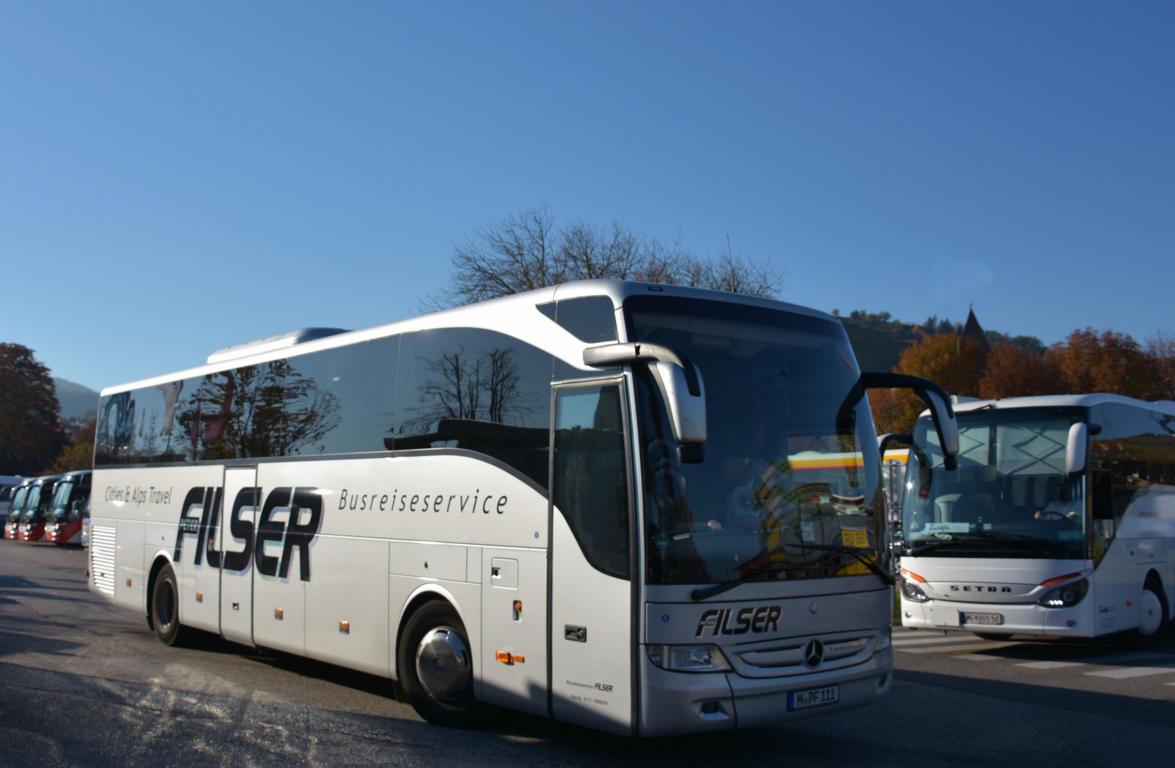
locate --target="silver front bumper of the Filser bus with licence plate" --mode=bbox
[640,648,893,736]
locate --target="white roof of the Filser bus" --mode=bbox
[101,279,837,397]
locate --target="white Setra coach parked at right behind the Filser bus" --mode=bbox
[901,395,1175,639]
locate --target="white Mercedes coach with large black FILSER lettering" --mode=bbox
[90,282,956,735]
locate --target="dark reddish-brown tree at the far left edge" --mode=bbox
[0,344,66,474]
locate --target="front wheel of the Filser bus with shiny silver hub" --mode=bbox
[397,602,475,727]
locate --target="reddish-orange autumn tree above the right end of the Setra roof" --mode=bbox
[1048,328,1156,399]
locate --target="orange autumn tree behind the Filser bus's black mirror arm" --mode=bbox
[870,334,988,432]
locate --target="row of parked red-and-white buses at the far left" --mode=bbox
[4,470,93,545]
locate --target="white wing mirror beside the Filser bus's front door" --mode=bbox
[584,342,706,450]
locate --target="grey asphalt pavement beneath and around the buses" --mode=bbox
[0,541,1175,768]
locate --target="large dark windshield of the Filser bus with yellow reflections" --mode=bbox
[625,297,881,584]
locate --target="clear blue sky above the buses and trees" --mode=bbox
[0,1,1175,389]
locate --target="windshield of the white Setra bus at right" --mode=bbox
[902,409,1088,559]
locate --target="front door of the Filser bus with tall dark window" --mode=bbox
[549,379,635,734]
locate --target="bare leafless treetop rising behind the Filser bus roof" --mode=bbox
[429,209,780,306]
